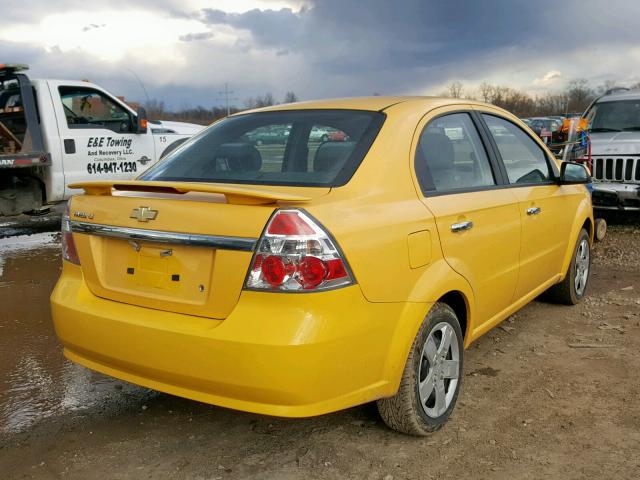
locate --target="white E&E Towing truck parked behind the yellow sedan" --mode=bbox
[0,64,204,217]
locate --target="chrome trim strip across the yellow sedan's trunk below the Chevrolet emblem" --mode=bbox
[70,221,257,252]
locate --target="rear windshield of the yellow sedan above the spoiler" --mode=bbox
[140,110,385,187]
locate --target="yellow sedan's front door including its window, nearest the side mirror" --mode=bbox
[482,111,575,301]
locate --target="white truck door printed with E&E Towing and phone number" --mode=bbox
[50,82,155,196]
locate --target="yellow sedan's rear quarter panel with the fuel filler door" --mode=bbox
[307,102,474,342]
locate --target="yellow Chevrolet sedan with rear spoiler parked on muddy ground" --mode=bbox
[51,97,593,435]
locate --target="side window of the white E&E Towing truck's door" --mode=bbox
[59,87,132,133]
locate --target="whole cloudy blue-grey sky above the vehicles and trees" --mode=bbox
[0,0,640,108]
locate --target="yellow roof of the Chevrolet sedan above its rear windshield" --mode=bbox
[237,96,492,115]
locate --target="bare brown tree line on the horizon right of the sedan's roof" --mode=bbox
[442,78,640,117]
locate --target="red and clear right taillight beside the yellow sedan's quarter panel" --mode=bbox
[245,210,354,292]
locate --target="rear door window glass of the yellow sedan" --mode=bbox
[415,113,496,192]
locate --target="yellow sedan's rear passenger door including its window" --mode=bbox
[415,106,521,335]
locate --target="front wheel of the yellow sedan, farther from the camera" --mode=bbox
[545,228,591,305]
